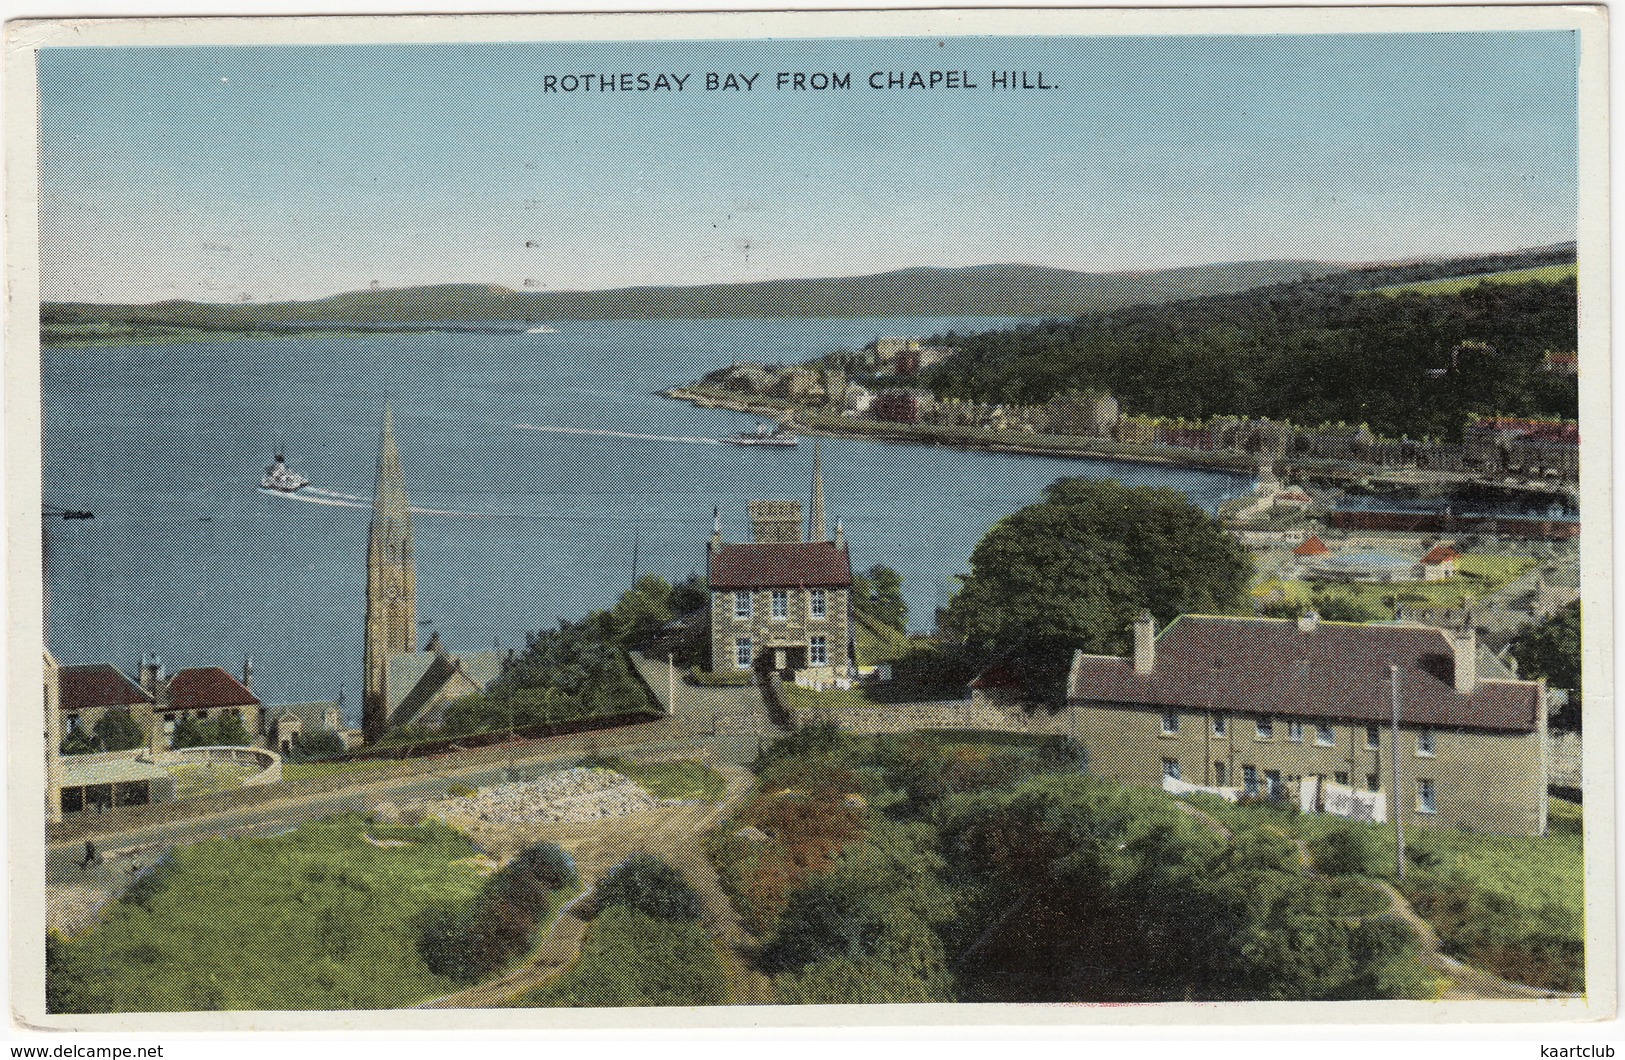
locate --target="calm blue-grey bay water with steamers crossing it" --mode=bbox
[44,319,1248,712]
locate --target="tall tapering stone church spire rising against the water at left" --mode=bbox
[361,405,418,743]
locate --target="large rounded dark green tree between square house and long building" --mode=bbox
[947,478,1251,699]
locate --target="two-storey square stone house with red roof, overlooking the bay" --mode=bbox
[709,497,852,681]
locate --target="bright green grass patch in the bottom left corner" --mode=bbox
[55,816,484,1013]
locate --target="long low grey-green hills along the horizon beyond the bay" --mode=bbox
[41,244,1575,335]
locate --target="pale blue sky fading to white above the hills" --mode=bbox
[39,33,1578,301]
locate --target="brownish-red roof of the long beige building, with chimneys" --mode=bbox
[1068,615,1544,733]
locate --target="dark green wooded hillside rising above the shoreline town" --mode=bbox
[923,245,1580,441]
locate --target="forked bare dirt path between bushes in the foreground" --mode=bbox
[418,764,774,1008]
